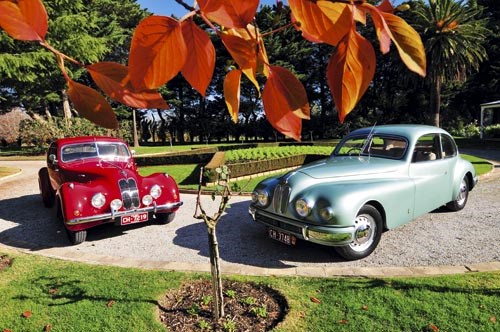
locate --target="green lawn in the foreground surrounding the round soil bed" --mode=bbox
[0,250,500,332]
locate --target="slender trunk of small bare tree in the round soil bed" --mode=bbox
[207,227,224,320]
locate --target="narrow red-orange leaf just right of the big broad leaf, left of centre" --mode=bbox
[182,20,215,97]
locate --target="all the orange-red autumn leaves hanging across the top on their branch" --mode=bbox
[0,0,426,140]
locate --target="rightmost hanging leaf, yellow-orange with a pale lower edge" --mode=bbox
[381,12,427,77]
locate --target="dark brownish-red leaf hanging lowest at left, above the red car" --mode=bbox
[67,80,118,129]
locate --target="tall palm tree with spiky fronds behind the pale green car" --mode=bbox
[416,0,488,127]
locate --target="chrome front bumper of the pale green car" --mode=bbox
[248,206,355,246]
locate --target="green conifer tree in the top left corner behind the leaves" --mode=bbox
[0,0,148,116]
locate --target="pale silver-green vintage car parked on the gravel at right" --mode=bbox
[249,125,478,260]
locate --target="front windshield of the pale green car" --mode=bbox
[333,134,408,159]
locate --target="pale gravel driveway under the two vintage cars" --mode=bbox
[0,151,500,269]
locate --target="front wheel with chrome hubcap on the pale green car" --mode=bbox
[335,205,382,260]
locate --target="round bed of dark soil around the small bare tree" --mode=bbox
[159,280,288,332]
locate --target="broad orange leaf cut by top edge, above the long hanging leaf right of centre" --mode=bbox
[288,0,352,46]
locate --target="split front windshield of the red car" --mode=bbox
[61,142,130,162]
